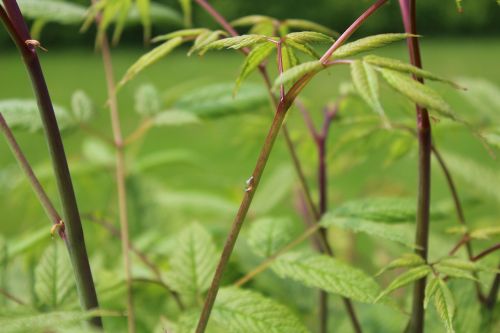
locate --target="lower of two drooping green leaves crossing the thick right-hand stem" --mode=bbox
[379,68,454,118]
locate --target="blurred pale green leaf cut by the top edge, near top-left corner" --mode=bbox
[17,0,87,24]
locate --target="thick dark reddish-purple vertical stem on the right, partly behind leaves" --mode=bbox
[399,0,432,333]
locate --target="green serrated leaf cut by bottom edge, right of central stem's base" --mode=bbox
[212,287,309,333]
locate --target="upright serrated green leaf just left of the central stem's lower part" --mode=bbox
[165,223,218,298]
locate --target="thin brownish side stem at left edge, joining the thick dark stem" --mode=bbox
[0,113,66,239]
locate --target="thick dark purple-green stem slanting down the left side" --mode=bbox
[0,0,102,327]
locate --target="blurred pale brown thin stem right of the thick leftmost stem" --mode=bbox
[97,26,135,333]
